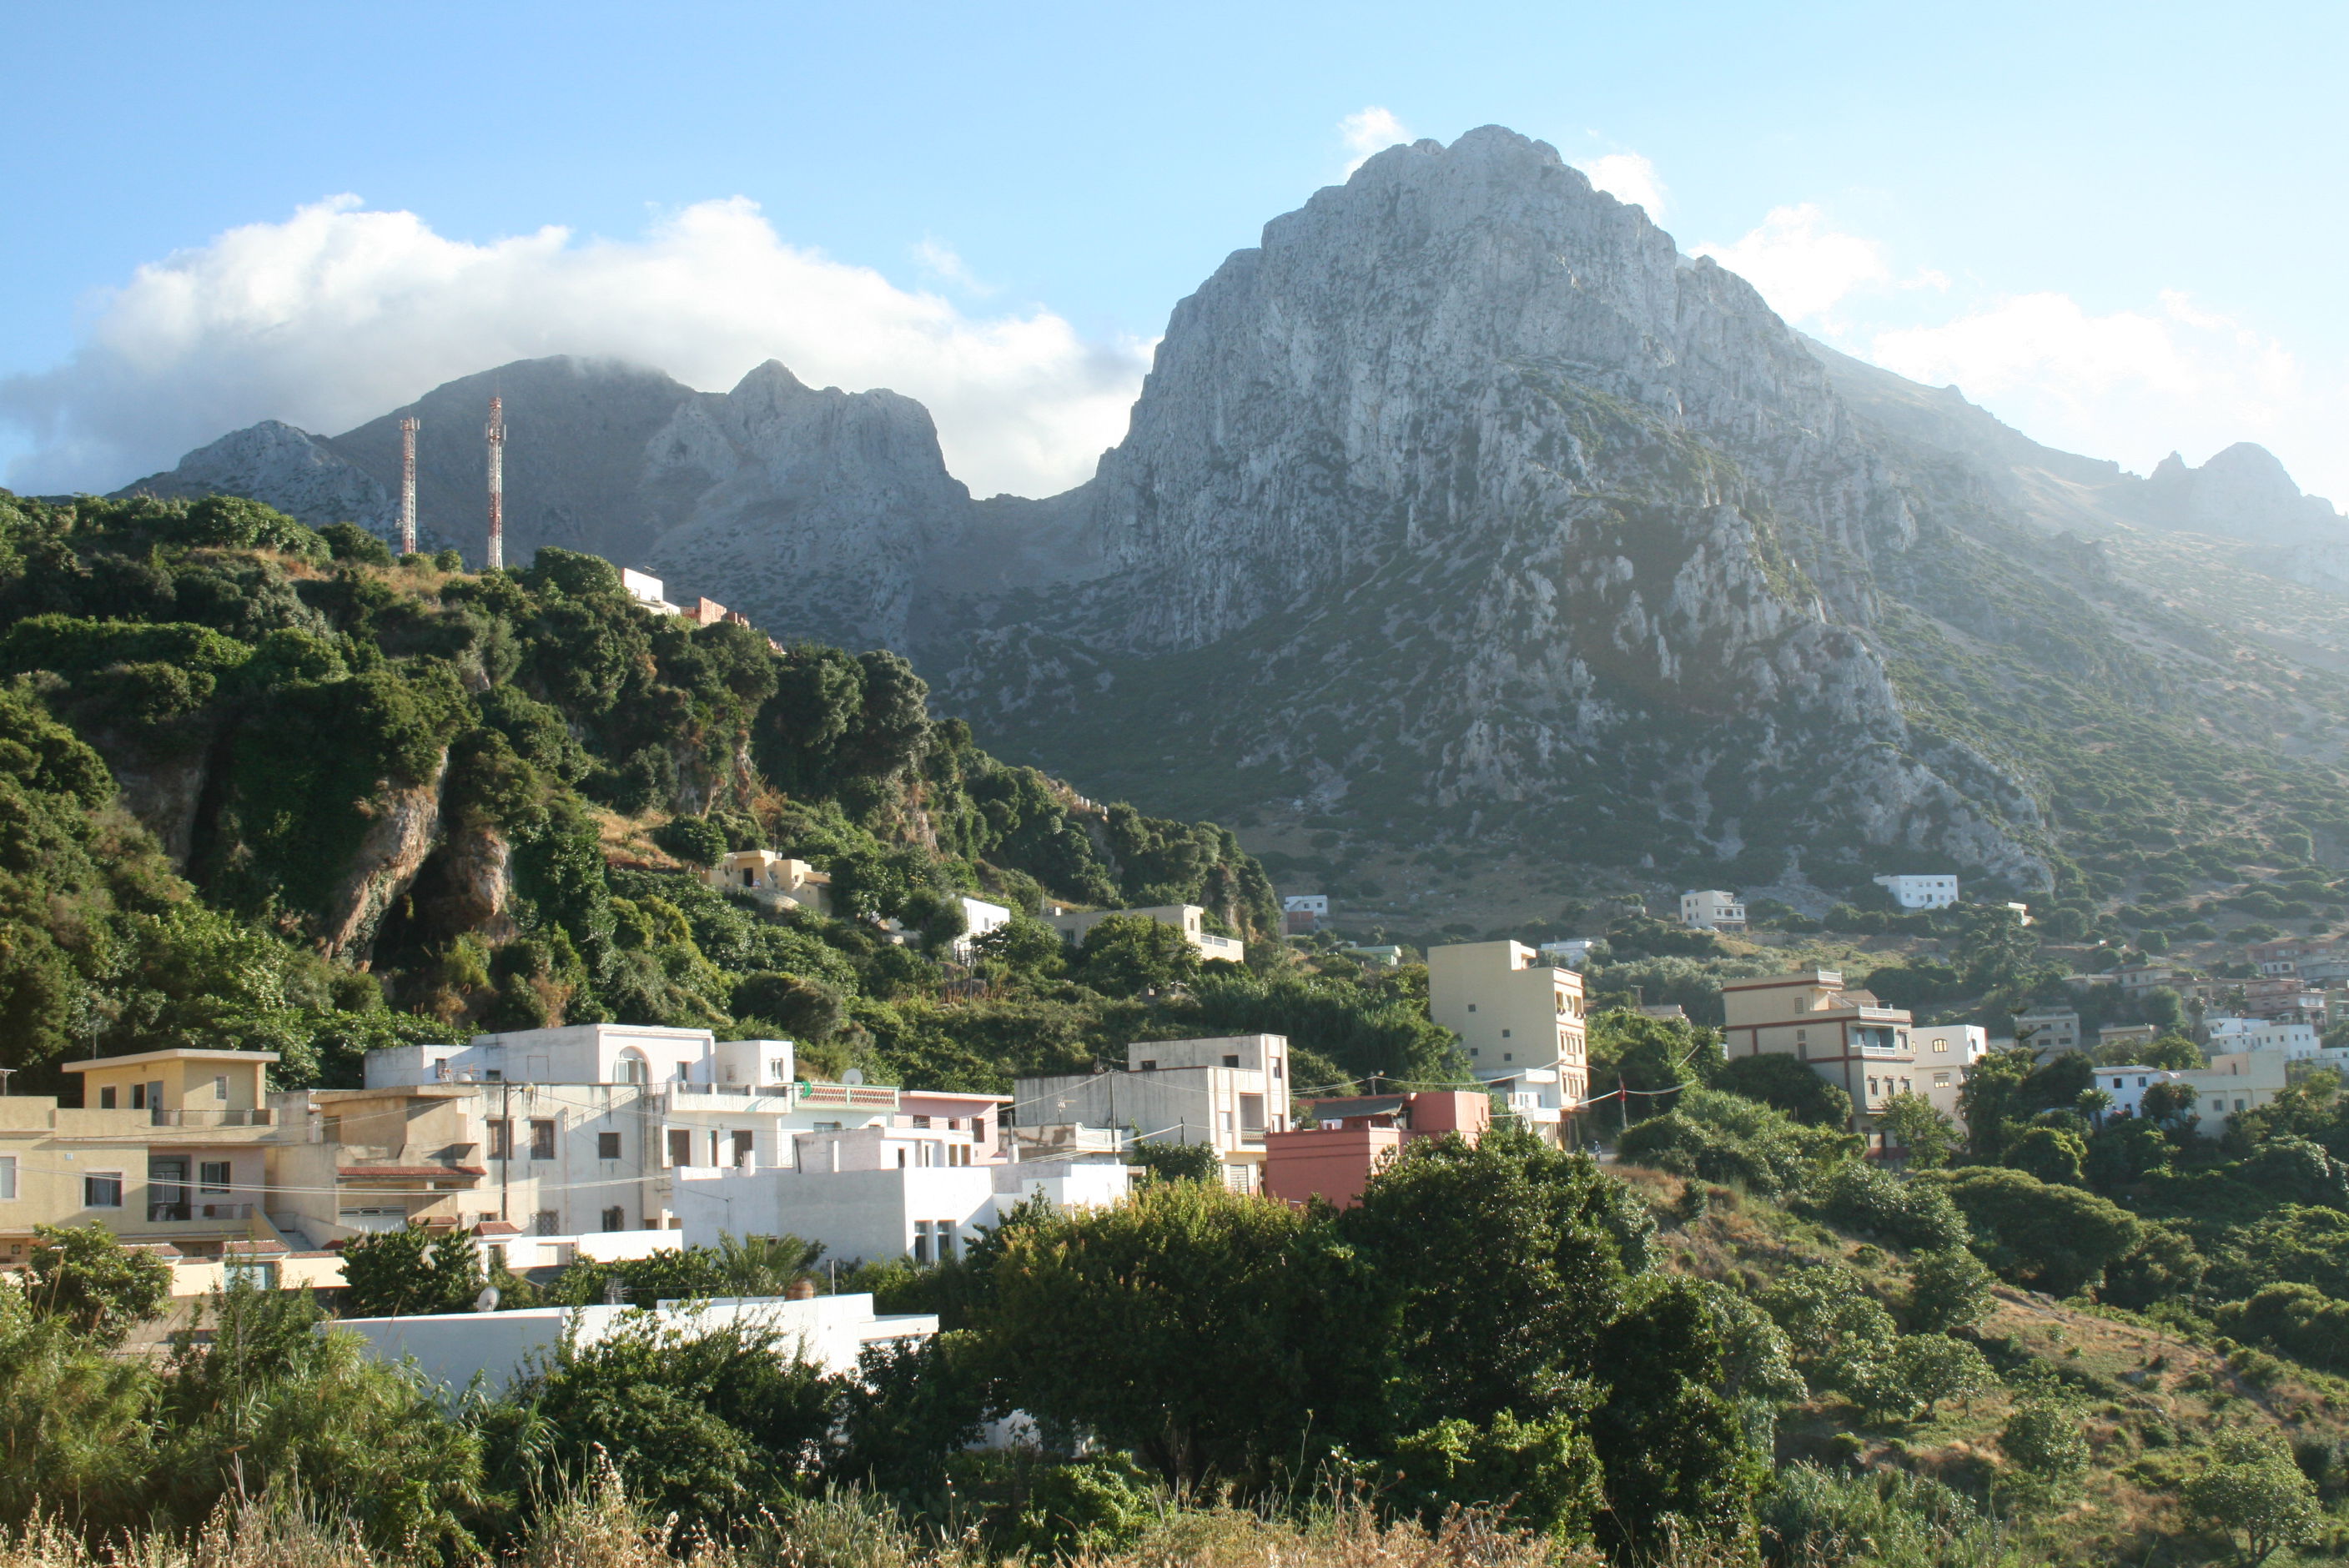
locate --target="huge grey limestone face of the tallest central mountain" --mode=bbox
[933,129,2044,882]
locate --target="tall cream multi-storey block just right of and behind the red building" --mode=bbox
[1428,942,1590,1143]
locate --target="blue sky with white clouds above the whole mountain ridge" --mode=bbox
[0,3,2349,500]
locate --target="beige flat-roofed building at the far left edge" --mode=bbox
[0,1049,282,1265]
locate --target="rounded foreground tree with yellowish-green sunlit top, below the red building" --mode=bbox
[973,1181,1391,1493]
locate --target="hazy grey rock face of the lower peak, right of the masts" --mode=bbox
[644,359,970,648]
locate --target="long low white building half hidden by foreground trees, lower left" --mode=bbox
[335,1296,938,1395]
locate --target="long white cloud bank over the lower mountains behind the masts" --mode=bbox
[0,197,1149,495]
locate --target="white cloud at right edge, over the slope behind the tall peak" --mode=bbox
[1870,291,2349,498]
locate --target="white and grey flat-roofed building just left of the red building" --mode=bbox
[1013,1035,1292,1193]
